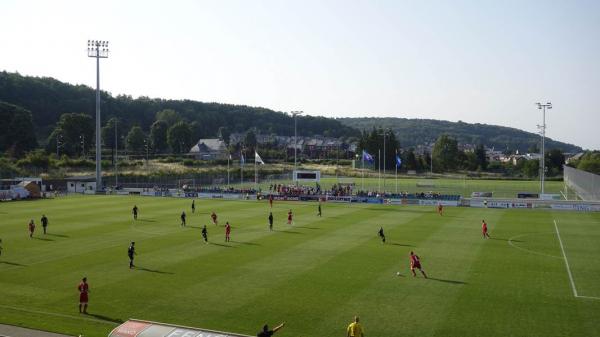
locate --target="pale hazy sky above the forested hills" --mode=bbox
[0,0,600,149]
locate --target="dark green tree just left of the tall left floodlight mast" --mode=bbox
[46,113,95,156]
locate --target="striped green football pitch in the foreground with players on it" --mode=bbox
[0,196,600,337]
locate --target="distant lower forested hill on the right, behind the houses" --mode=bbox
[337,118,582,152]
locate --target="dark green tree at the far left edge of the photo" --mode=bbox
[0,102,37,156]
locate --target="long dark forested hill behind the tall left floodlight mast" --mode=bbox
[0,72,359,143]
